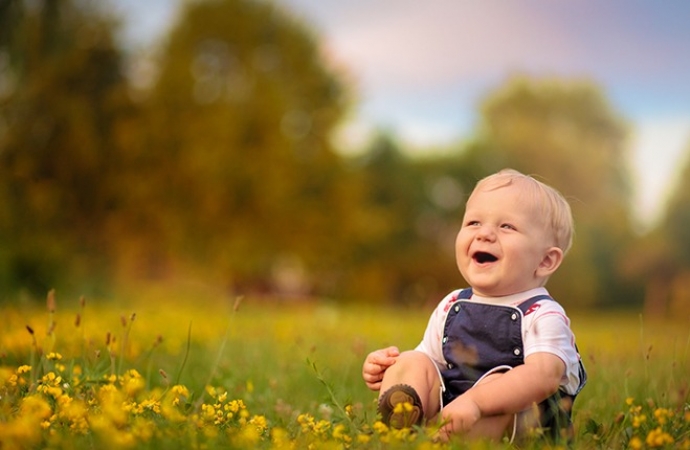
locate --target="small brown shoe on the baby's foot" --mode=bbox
[378,384,424,429]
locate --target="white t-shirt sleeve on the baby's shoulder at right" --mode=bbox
[523,300,580,394]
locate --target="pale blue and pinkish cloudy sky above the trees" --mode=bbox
[111,0,690,230]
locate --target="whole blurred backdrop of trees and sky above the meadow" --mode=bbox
[0,0,690,316]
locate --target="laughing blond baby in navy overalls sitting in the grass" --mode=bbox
[362,169,587,441]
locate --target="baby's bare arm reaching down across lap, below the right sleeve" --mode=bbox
[440,352,565,438]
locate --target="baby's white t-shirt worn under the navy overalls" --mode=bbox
[416,287,580,395]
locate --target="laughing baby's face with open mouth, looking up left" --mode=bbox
[455,184,554,297]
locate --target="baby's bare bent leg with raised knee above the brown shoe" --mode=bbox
[379,351,441,418]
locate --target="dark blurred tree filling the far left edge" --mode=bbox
[0,0,129,295]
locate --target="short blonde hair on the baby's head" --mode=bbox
[474,169,575,254]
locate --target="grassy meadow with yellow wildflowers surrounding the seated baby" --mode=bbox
[0,290,690,450]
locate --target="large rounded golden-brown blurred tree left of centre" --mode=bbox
[140,0,354,296]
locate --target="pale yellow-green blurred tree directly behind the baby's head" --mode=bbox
[456,77,641,306]
